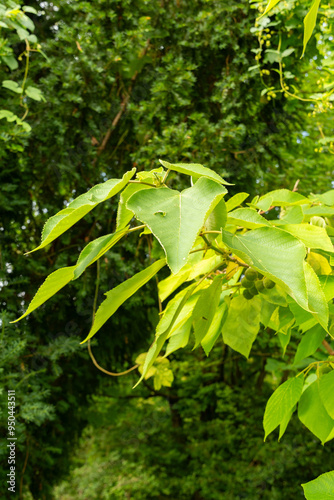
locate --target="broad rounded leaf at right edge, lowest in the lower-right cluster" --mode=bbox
[298,381,334,444]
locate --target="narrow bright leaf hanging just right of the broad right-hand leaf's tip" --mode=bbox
[304,261,329,331]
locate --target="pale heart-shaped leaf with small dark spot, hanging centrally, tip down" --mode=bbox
[127,177,226,274]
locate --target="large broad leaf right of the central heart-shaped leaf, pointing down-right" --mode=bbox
[222,227,308,309]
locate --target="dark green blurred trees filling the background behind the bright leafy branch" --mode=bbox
[0,0,334,500]
